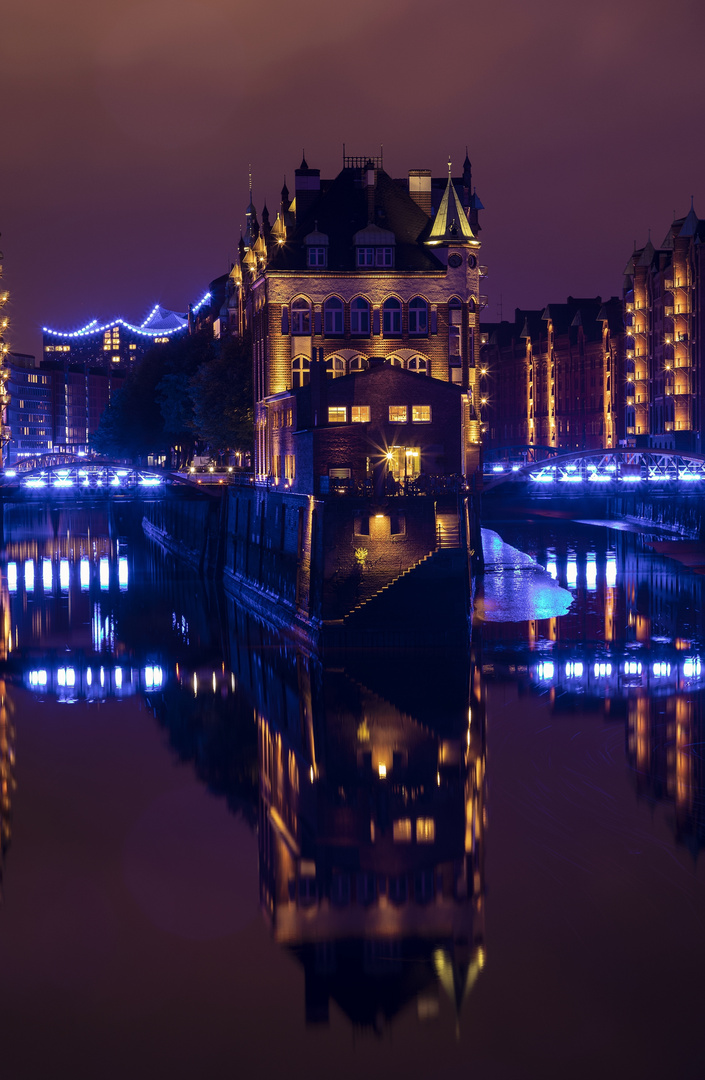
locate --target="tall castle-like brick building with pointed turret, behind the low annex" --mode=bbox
[224,149,485,485]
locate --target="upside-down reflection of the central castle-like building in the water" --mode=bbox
[250,639,486,1029]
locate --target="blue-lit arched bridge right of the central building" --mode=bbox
[484,448,705,498]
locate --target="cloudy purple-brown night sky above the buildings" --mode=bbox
[0,0,705,353]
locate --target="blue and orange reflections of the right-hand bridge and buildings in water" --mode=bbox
[475,527,705,855]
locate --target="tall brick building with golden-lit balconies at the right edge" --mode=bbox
[624,206,705,453]
